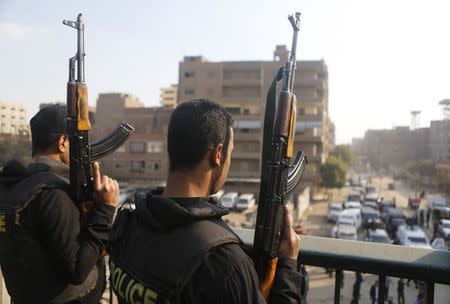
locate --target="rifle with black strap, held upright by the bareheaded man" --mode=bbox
[253,13,308,299]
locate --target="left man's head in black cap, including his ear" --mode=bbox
[30,105,69,164]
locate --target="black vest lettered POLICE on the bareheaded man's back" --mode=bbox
[109,198,240,304]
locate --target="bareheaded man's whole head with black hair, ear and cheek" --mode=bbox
[167,99,233,194]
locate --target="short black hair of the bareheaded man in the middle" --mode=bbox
[167,99,233,171]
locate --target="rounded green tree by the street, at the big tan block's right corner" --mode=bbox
[320,155,348,188]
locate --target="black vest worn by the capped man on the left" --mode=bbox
[0,161,98,303]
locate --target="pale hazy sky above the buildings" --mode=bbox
[0,0,450,143]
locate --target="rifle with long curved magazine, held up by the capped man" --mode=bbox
[63,14,134,203]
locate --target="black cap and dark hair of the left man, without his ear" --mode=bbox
[30,105,66,156]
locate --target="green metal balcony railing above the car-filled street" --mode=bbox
[233,228,450,304]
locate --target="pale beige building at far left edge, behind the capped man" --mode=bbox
[0,101,29,135]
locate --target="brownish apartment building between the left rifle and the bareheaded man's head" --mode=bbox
[93,93,172,187]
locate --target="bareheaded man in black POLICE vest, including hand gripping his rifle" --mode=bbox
[110,100,301,303]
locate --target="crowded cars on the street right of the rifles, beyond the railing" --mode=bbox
[327,189,450,250]
